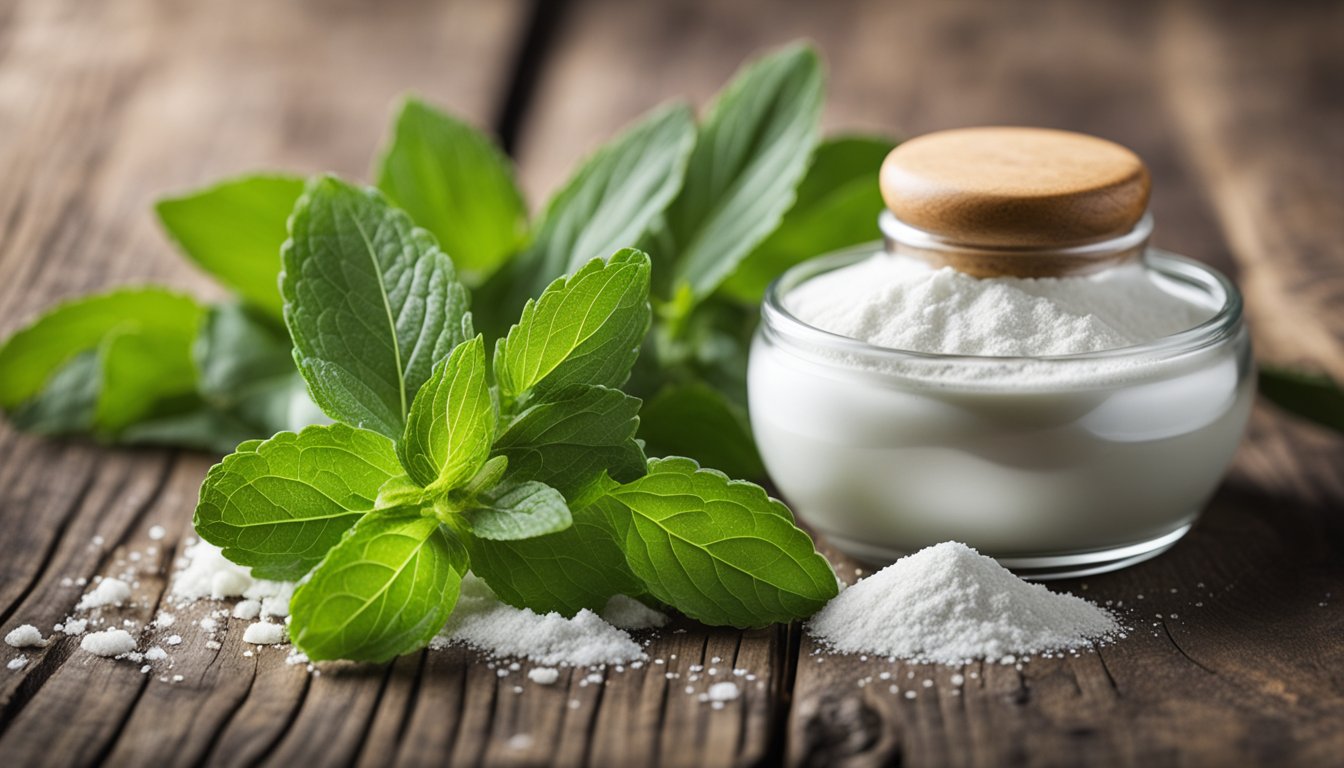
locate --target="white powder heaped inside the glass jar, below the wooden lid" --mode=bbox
[786,253,1212,356]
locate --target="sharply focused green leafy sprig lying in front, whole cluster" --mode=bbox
[195,176,836,662]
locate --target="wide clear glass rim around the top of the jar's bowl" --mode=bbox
[761,241,1243,366]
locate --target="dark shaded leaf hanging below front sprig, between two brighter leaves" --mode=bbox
[466,499,642,616]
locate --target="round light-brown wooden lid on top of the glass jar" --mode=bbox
[880,128,1150,247]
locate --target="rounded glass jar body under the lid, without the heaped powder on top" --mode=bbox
[749,238,1254,578]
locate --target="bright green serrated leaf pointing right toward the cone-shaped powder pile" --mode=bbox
[607,459,836,627]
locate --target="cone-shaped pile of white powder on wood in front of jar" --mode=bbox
[808,542,1120,664]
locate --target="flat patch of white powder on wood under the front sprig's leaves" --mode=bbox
[433,574,645,666]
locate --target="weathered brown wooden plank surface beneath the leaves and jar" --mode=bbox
[0,0,1344,767]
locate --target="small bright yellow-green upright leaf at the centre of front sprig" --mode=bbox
[396,336,495,491]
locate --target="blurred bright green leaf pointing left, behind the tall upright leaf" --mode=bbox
[155,175,304,319]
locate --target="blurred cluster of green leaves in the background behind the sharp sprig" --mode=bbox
[0,46,891,477]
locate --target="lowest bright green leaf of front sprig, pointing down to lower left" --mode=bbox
[289,508,468,663]
